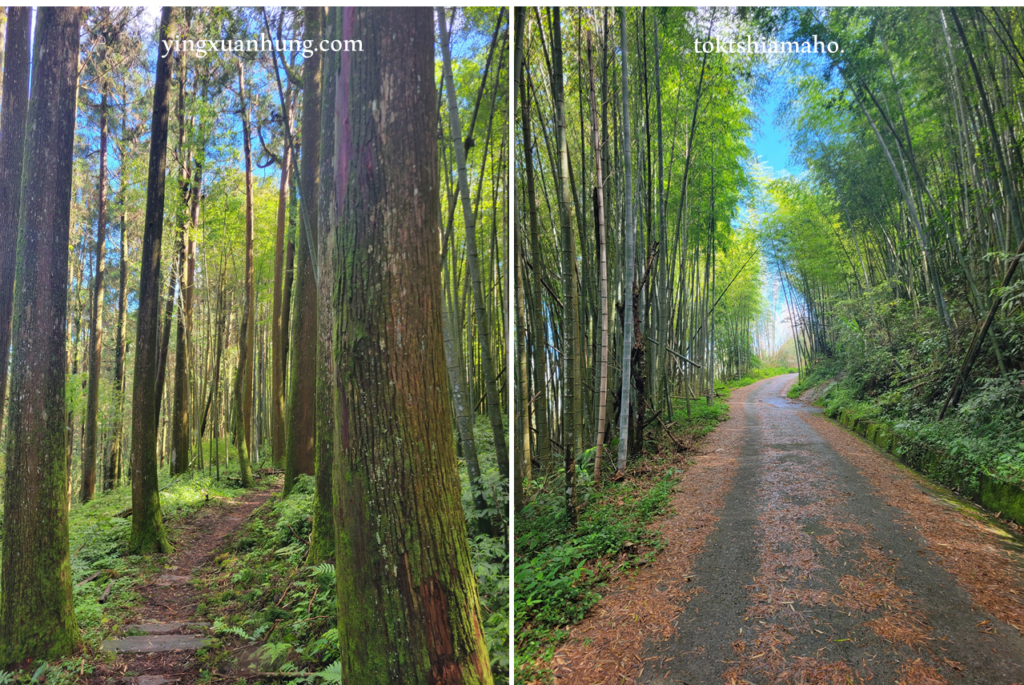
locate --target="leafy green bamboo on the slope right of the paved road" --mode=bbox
[751,6,1024,417]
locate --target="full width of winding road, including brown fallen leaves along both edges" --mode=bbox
[551,375,1024,685]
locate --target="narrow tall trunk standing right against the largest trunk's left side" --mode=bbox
[311,5,340,559]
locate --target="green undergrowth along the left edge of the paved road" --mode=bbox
[512,369,796,683]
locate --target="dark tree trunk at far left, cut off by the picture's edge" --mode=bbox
[0,5,32,428]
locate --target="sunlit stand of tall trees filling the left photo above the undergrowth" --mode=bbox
[0,6,507,683]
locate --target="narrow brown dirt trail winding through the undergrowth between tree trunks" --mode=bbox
[90,484,281,684]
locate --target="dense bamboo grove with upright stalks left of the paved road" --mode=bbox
[512,6,767,521]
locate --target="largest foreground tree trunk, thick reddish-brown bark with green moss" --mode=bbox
[327,7,494,685]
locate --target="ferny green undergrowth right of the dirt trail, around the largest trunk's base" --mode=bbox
[196,466,510,683]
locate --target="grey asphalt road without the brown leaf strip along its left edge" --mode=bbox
[640,375,1024,685]
